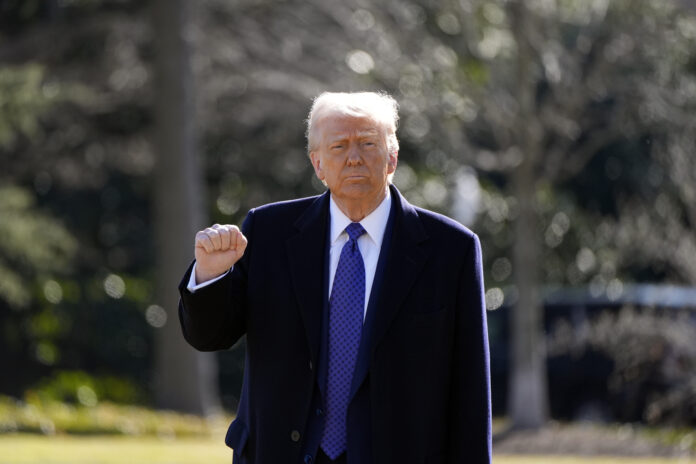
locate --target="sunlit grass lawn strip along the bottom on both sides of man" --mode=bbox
[0,434,696,464]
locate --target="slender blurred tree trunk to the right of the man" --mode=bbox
[508,0,548,428]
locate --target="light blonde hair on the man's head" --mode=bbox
[305,92,399,155]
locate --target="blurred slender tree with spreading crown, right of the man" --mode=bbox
[372,1,690,427]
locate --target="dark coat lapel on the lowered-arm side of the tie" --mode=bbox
[351,186,428,396]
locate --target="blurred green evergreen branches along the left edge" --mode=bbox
[0,65,77,391]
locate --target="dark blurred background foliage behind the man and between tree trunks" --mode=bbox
[0,0,696,422]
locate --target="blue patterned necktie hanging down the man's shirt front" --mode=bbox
[321,222,365,459]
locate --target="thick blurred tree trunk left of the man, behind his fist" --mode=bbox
[152,0,219,414]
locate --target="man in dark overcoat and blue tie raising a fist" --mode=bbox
[180,93,491,464]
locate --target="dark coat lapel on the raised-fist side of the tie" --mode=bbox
[286,191,329,372]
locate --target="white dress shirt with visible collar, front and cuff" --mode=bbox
[186,192,391,320]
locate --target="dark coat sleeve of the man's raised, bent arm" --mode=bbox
[179,210,254,351]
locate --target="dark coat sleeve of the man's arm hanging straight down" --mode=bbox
[448,235,492,464]
